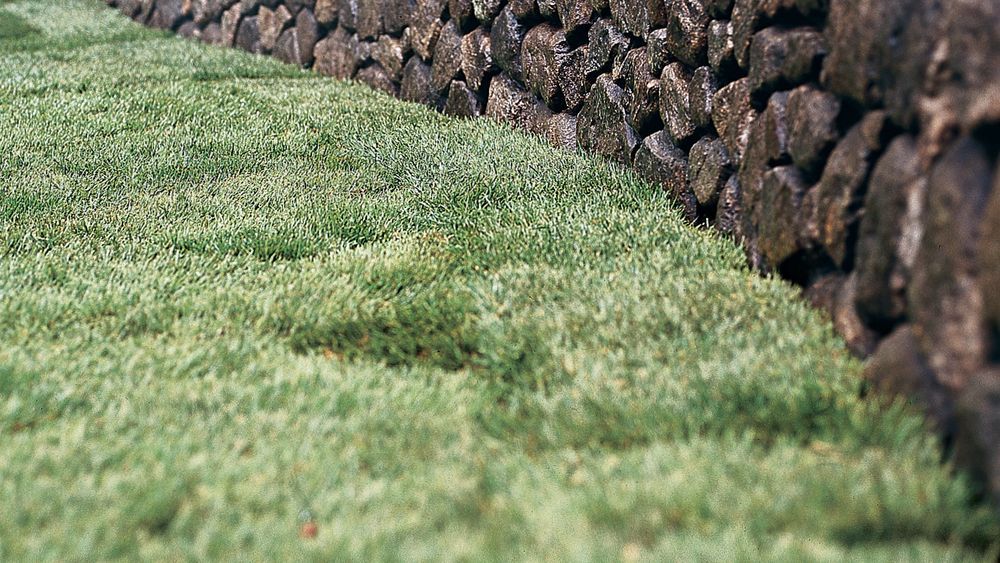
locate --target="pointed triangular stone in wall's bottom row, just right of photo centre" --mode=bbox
[576,74,639,164]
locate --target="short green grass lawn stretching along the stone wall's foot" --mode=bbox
[0,0,998,561]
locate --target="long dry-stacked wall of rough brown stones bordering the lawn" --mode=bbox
[107,0,1000,506]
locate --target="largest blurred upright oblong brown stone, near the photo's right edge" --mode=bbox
[909,138,991,392]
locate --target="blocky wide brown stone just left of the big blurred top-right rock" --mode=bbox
[748,27,826,98]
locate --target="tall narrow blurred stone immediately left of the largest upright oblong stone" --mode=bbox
[855,135,924,330]
